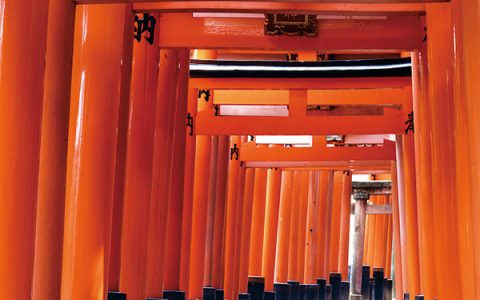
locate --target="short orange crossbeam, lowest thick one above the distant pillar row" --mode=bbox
[241,137,395,162]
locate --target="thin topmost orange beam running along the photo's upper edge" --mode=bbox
[129,0,425,15]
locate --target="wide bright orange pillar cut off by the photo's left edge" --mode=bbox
[0,0,49,299]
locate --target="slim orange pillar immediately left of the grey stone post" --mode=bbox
[338,171,352,280]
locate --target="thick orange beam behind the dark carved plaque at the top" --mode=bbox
[157,13,423,51]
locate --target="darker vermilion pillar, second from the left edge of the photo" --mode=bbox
[32,0,75,300]
